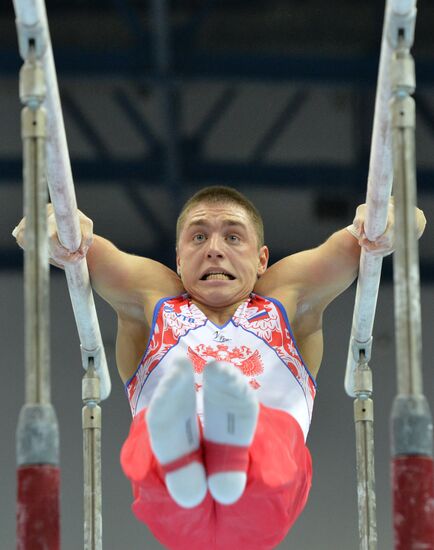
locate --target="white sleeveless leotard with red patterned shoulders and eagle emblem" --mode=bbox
[125,294,316,439]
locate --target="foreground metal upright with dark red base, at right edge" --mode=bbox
[389,0,434,550]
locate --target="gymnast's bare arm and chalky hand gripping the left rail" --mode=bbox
[13,205,183,321]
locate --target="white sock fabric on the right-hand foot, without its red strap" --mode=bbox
[203,362,259,504]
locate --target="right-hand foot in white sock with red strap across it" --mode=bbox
[204,363,259,504]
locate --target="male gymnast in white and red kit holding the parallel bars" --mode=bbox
[13,186,426,550]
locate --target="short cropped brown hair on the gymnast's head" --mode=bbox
[176,185,264,248]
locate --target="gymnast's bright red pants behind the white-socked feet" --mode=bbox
[121,405,312,550]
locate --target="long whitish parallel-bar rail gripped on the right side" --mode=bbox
[345,0,416,397]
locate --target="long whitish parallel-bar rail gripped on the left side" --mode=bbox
[14,0,111,399]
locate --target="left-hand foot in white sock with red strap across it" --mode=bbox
[146,360,207,508]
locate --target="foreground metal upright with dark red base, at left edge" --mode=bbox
[13,5,60,550]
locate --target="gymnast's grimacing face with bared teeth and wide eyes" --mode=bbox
[177,202,268,308]
